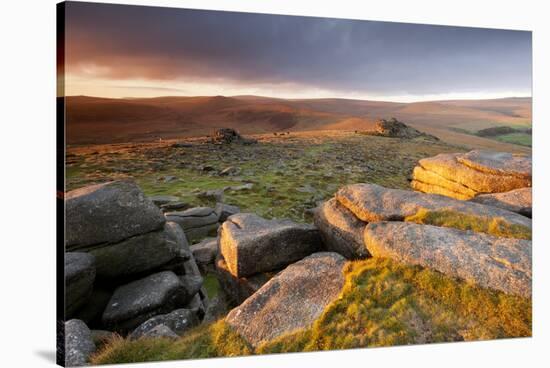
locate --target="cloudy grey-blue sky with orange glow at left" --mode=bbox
[65,2,532,102]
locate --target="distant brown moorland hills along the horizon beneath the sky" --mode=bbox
[66,96,531,150]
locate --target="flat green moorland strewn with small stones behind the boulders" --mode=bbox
[66,131,464,222]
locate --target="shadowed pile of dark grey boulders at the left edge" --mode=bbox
[65,181,211,366]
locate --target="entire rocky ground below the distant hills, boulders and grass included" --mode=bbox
[65,129,532,365]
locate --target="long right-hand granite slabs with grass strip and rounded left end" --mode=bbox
[314,183,532,298]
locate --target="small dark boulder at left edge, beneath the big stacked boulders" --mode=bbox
[65,252,96,316]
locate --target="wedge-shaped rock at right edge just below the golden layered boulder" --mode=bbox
[471,188,533,217]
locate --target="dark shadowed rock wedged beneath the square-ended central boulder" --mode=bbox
[216,257,277,305]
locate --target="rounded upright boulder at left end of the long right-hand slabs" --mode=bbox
[313,198,370,259]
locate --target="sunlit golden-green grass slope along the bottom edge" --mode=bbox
[92,258,532,364]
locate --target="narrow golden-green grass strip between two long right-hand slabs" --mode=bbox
[405,209,531,240]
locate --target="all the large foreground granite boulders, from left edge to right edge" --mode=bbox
[65,151,532,365]
